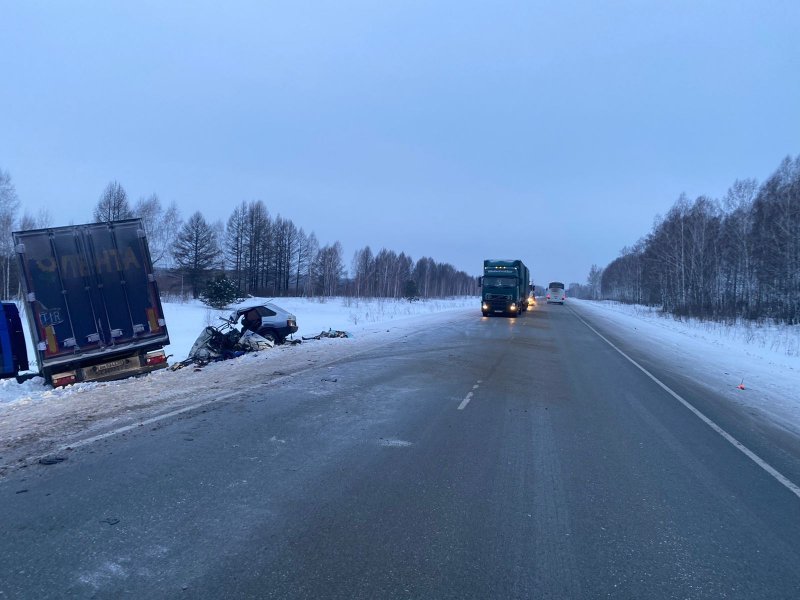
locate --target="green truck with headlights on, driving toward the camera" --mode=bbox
[480,259,531,317]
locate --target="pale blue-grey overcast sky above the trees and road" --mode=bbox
[0,0,800,283]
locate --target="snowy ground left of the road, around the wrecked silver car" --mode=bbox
[0,298,476,476]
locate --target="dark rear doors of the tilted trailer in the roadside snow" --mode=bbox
[13,219,169,380]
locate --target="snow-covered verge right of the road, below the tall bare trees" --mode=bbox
[569,299,800,436]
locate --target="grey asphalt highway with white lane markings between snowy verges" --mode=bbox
[0,305,800,599]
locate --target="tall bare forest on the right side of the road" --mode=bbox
[590,156,800,324]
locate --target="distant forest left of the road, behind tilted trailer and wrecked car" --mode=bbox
[0,169,477,299]
